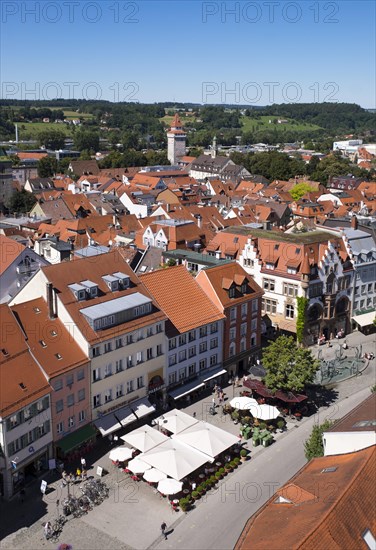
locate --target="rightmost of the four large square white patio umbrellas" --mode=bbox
[172,422,239,458]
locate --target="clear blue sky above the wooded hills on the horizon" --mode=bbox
[0,0,376,108]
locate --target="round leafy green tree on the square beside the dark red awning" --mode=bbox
[263,336,319,391]
